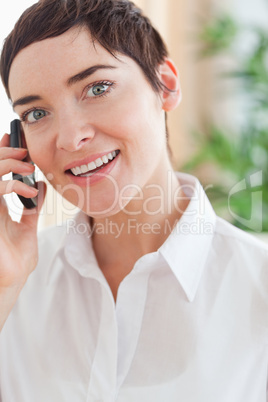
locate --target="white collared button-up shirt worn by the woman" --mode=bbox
[0,174,268,402]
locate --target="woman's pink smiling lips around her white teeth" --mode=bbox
[65,152,120,187]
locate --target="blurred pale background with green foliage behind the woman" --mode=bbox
[0,0,268,237]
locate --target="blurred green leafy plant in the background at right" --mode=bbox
[184,16,268,231]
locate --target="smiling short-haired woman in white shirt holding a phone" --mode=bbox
[0,0,268,402]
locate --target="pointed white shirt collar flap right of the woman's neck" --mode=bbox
[159,173,216,301]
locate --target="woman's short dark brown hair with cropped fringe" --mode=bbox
[0,0,168,98]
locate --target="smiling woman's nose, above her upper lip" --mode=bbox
[56,108,95,152]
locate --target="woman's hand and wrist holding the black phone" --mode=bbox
[0,134,46,328]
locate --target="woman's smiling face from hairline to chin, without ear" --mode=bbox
[9,28,177,217]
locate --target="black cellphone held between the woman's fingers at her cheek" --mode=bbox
[10,119,37,209]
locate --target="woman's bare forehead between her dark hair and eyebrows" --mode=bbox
[9,27,136,100]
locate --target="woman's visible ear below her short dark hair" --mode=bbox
[159,58,181,112]
